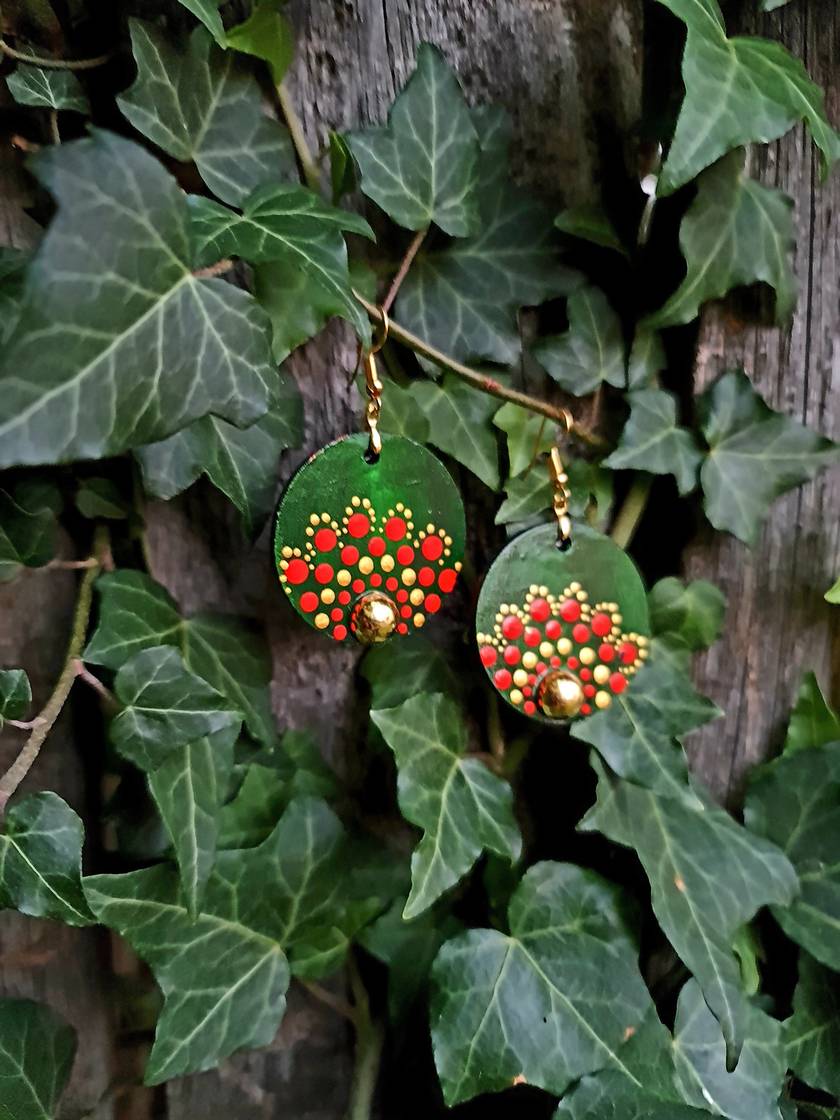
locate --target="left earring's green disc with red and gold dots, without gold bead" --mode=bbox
[274,433,466,642]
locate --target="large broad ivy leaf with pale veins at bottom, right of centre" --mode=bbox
[430,864,651,1107]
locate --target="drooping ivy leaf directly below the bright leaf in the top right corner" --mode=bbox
[645,151,796,327]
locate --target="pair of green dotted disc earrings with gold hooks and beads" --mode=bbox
[274,327,648,724]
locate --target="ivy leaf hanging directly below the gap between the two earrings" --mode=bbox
[371,692,522,921]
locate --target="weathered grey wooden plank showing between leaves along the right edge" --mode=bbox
[687,0,840,803]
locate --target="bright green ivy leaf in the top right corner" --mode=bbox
[657,0,840,195]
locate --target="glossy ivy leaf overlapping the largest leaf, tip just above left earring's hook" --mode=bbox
[190,185,373,339]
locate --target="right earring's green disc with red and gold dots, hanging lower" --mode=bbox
[476,525,650,724]
